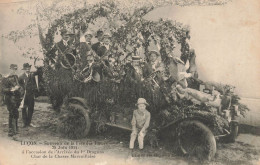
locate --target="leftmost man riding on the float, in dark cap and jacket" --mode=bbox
[46,29,76,64]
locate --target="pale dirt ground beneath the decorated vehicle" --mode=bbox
[0,97,260,165]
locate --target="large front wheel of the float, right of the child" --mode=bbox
[177,120,216,160]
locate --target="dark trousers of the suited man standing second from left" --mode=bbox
[22,95,34,126]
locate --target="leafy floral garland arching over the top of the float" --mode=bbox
[43,1,189,51]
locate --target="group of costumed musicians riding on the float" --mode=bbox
[46,29,215,104]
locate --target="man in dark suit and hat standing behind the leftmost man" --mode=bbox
[19,63,37,127]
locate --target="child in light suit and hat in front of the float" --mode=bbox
[129,98,151,149]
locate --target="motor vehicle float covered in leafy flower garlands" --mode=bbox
[31,1,248,160]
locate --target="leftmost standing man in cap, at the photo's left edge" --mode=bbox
[2,64,22,136]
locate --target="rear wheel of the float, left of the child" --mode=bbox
[60,98,91,139]
